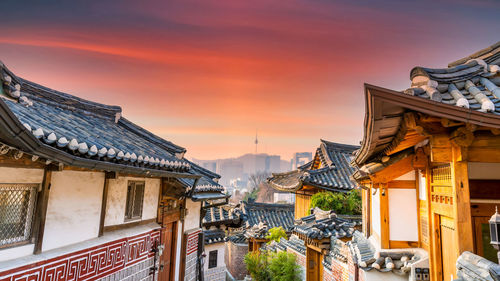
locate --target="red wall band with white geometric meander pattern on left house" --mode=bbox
[0,230,160,281]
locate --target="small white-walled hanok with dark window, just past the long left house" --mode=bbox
[203,204,242,281]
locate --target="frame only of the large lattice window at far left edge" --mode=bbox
[0,183,40,249]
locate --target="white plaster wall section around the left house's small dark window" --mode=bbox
[104,177,161,226]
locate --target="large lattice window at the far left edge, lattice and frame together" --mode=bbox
[0,184,38,247]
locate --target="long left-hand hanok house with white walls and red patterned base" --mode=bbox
[0,61,225,280]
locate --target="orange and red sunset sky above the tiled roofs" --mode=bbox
[0,0,500,159]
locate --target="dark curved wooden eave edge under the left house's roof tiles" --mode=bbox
[0,99,201,179]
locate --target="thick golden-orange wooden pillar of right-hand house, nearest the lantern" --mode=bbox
[451,145,474,255]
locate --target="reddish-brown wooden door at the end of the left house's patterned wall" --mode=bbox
[158,222,177,281]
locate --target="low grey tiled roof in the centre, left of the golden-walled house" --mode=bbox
[241,202,294,231]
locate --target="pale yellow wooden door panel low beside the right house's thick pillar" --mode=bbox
[440,216,457,281]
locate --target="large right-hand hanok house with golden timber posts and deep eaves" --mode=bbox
[353,42,500,280]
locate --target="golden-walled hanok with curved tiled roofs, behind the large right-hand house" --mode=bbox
[268,140,361,281]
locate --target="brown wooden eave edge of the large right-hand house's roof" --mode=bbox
[354,83,500,165]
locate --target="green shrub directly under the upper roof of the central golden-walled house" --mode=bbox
[311,190,361,215]
